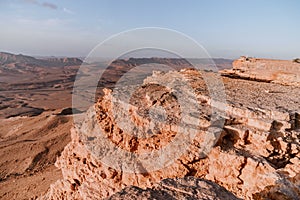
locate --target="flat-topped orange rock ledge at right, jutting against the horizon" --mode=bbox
[222,56,300,86]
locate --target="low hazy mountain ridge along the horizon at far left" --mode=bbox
[0,52,82,67]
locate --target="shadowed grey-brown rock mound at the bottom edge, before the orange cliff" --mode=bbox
[108,177,239,200]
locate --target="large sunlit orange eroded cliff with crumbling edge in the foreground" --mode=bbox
[41,70,300,199]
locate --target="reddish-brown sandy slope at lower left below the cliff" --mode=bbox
[0,112,72,199]
